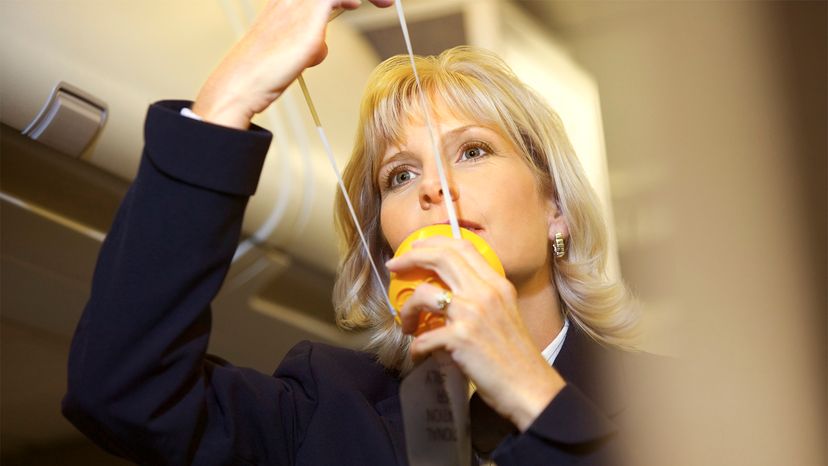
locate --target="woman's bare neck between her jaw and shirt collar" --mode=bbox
[515,268,564,351]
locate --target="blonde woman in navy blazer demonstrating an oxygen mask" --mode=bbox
[63,0,633,465]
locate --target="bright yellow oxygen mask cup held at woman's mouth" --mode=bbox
[388,225,506,336]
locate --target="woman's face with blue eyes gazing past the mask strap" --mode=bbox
[378,108,562,285]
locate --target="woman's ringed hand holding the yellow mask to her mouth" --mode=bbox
[387,236,565,431]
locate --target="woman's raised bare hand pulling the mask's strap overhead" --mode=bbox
[193,0,393,129]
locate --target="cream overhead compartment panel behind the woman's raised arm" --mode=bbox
[0,0,378,272]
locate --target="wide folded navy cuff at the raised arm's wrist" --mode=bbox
[144,100,272,196]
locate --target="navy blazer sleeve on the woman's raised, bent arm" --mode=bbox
[62,101,316,465]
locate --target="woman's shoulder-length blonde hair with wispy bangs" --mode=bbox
[333,46,636,371]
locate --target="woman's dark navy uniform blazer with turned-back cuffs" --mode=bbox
[63,101,623,466]
